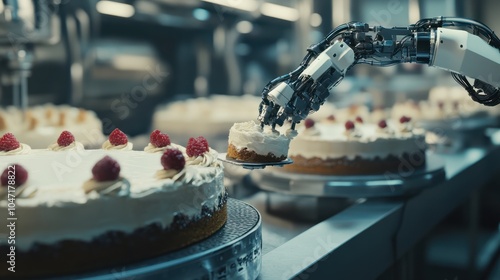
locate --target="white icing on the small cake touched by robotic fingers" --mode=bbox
[228,121,293,157]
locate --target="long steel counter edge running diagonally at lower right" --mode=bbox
[236,146,500,279]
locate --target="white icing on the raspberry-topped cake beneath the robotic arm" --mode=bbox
[288,123,425,159]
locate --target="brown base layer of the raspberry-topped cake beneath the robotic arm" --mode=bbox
[283,151,426,175]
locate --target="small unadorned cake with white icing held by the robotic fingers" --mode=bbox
[227,121,295,162]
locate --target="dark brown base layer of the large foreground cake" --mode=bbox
[0,197,227,278]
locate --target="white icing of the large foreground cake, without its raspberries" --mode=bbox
[0,150,225,250]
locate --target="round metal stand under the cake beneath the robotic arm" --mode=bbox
[250,154,445,198]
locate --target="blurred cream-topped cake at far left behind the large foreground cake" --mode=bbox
[0,104,105,149]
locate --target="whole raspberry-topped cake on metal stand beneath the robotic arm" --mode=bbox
[283,118,426,175]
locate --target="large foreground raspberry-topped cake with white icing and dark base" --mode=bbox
[0,130,227,277]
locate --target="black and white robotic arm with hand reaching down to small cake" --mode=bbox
[259,17,500,129]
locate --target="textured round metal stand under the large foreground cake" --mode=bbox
[62,198,262,280]
